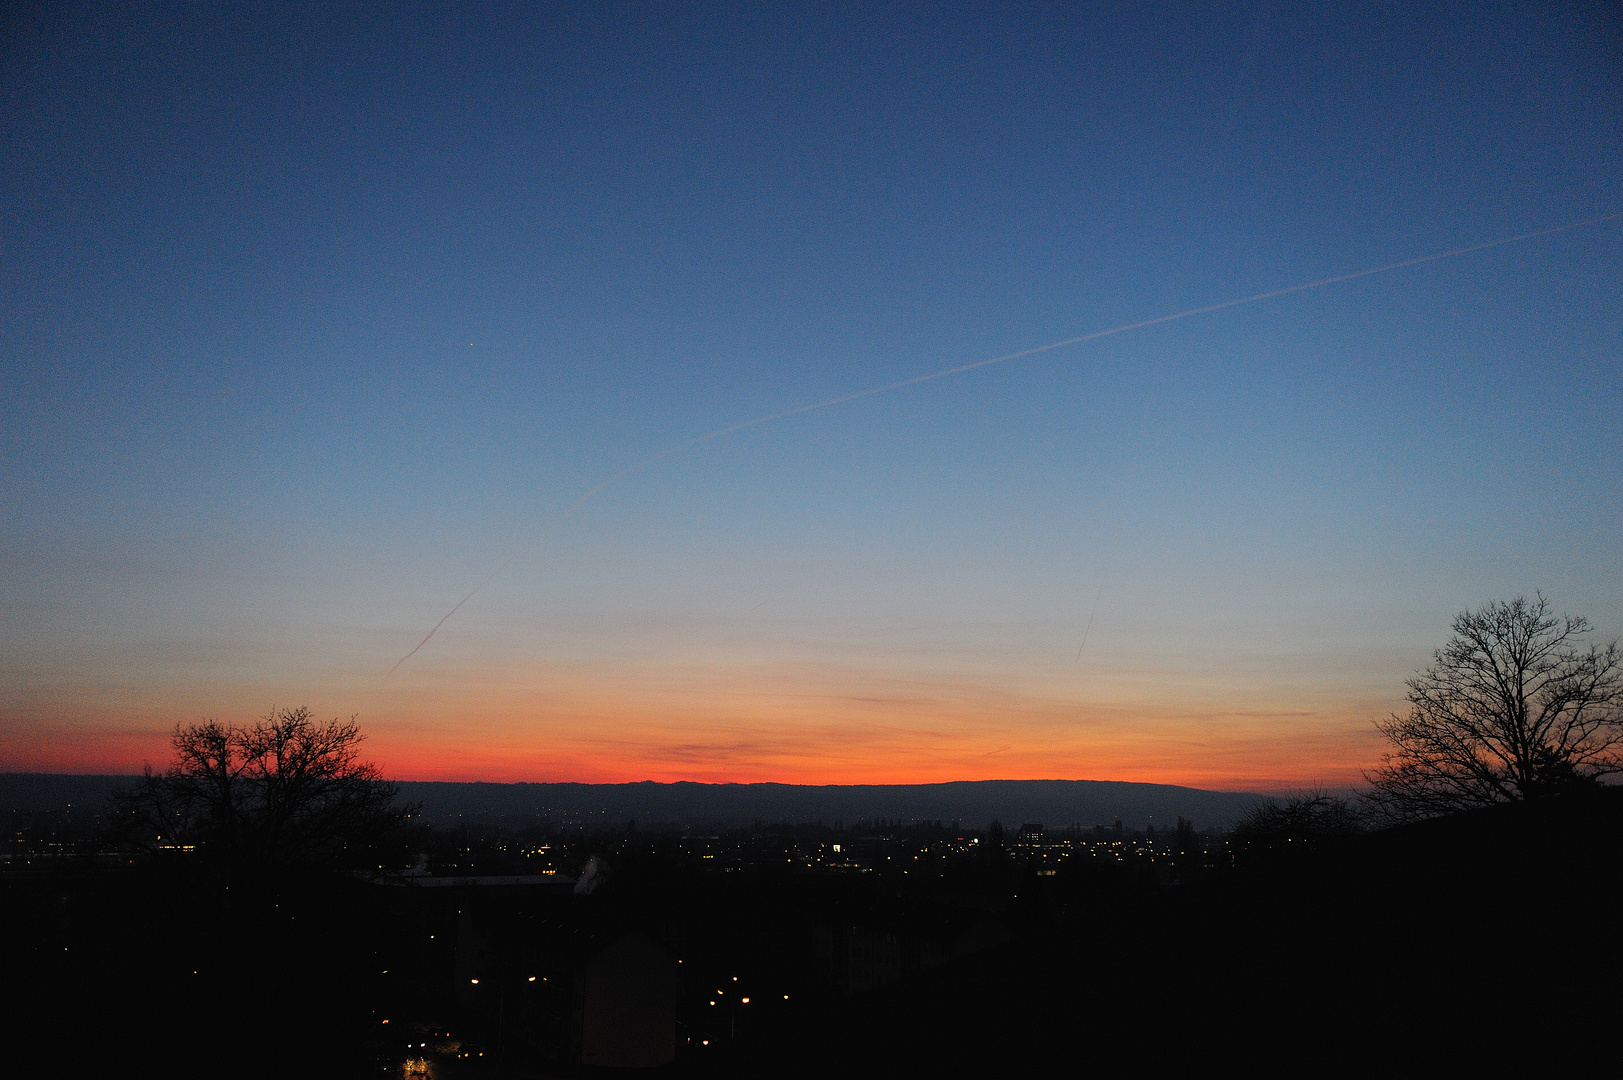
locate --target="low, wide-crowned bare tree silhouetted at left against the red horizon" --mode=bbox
[115,708,411,880]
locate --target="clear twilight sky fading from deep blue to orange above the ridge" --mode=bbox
[0,3,1623,791]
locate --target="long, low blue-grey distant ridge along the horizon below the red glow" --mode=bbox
[0,773,1258,828]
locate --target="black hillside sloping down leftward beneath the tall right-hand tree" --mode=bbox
[759,789,1623,1077]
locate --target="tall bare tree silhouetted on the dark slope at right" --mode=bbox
[1365,594,1623,820]
